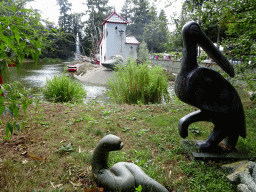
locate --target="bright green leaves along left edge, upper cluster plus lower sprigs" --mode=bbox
[0,0,47,139]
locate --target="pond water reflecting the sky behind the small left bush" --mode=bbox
[2,62,109,102]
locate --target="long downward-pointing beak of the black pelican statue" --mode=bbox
[194,25,235,77]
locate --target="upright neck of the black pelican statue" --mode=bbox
[181,42,198,74]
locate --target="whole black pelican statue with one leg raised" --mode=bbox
[175,21,246,151]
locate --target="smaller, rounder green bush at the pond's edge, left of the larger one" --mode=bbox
[42,74,86,102]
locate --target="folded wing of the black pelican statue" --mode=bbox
[187,67,245,137]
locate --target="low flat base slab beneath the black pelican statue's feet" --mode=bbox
[181,140,253,161]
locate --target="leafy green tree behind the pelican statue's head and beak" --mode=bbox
[169,0,256,90]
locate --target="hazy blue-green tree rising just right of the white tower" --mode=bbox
[121,0,169,52]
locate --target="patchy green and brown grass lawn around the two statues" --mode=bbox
[0,88,256,192]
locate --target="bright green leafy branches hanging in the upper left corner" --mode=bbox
[0,0,46,68]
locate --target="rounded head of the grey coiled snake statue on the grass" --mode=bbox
[98,134,123,151]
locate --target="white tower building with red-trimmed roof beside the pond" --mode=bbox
[99,12,140,64]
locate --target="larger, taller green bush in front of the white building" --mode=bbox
[107,59,170,104]
